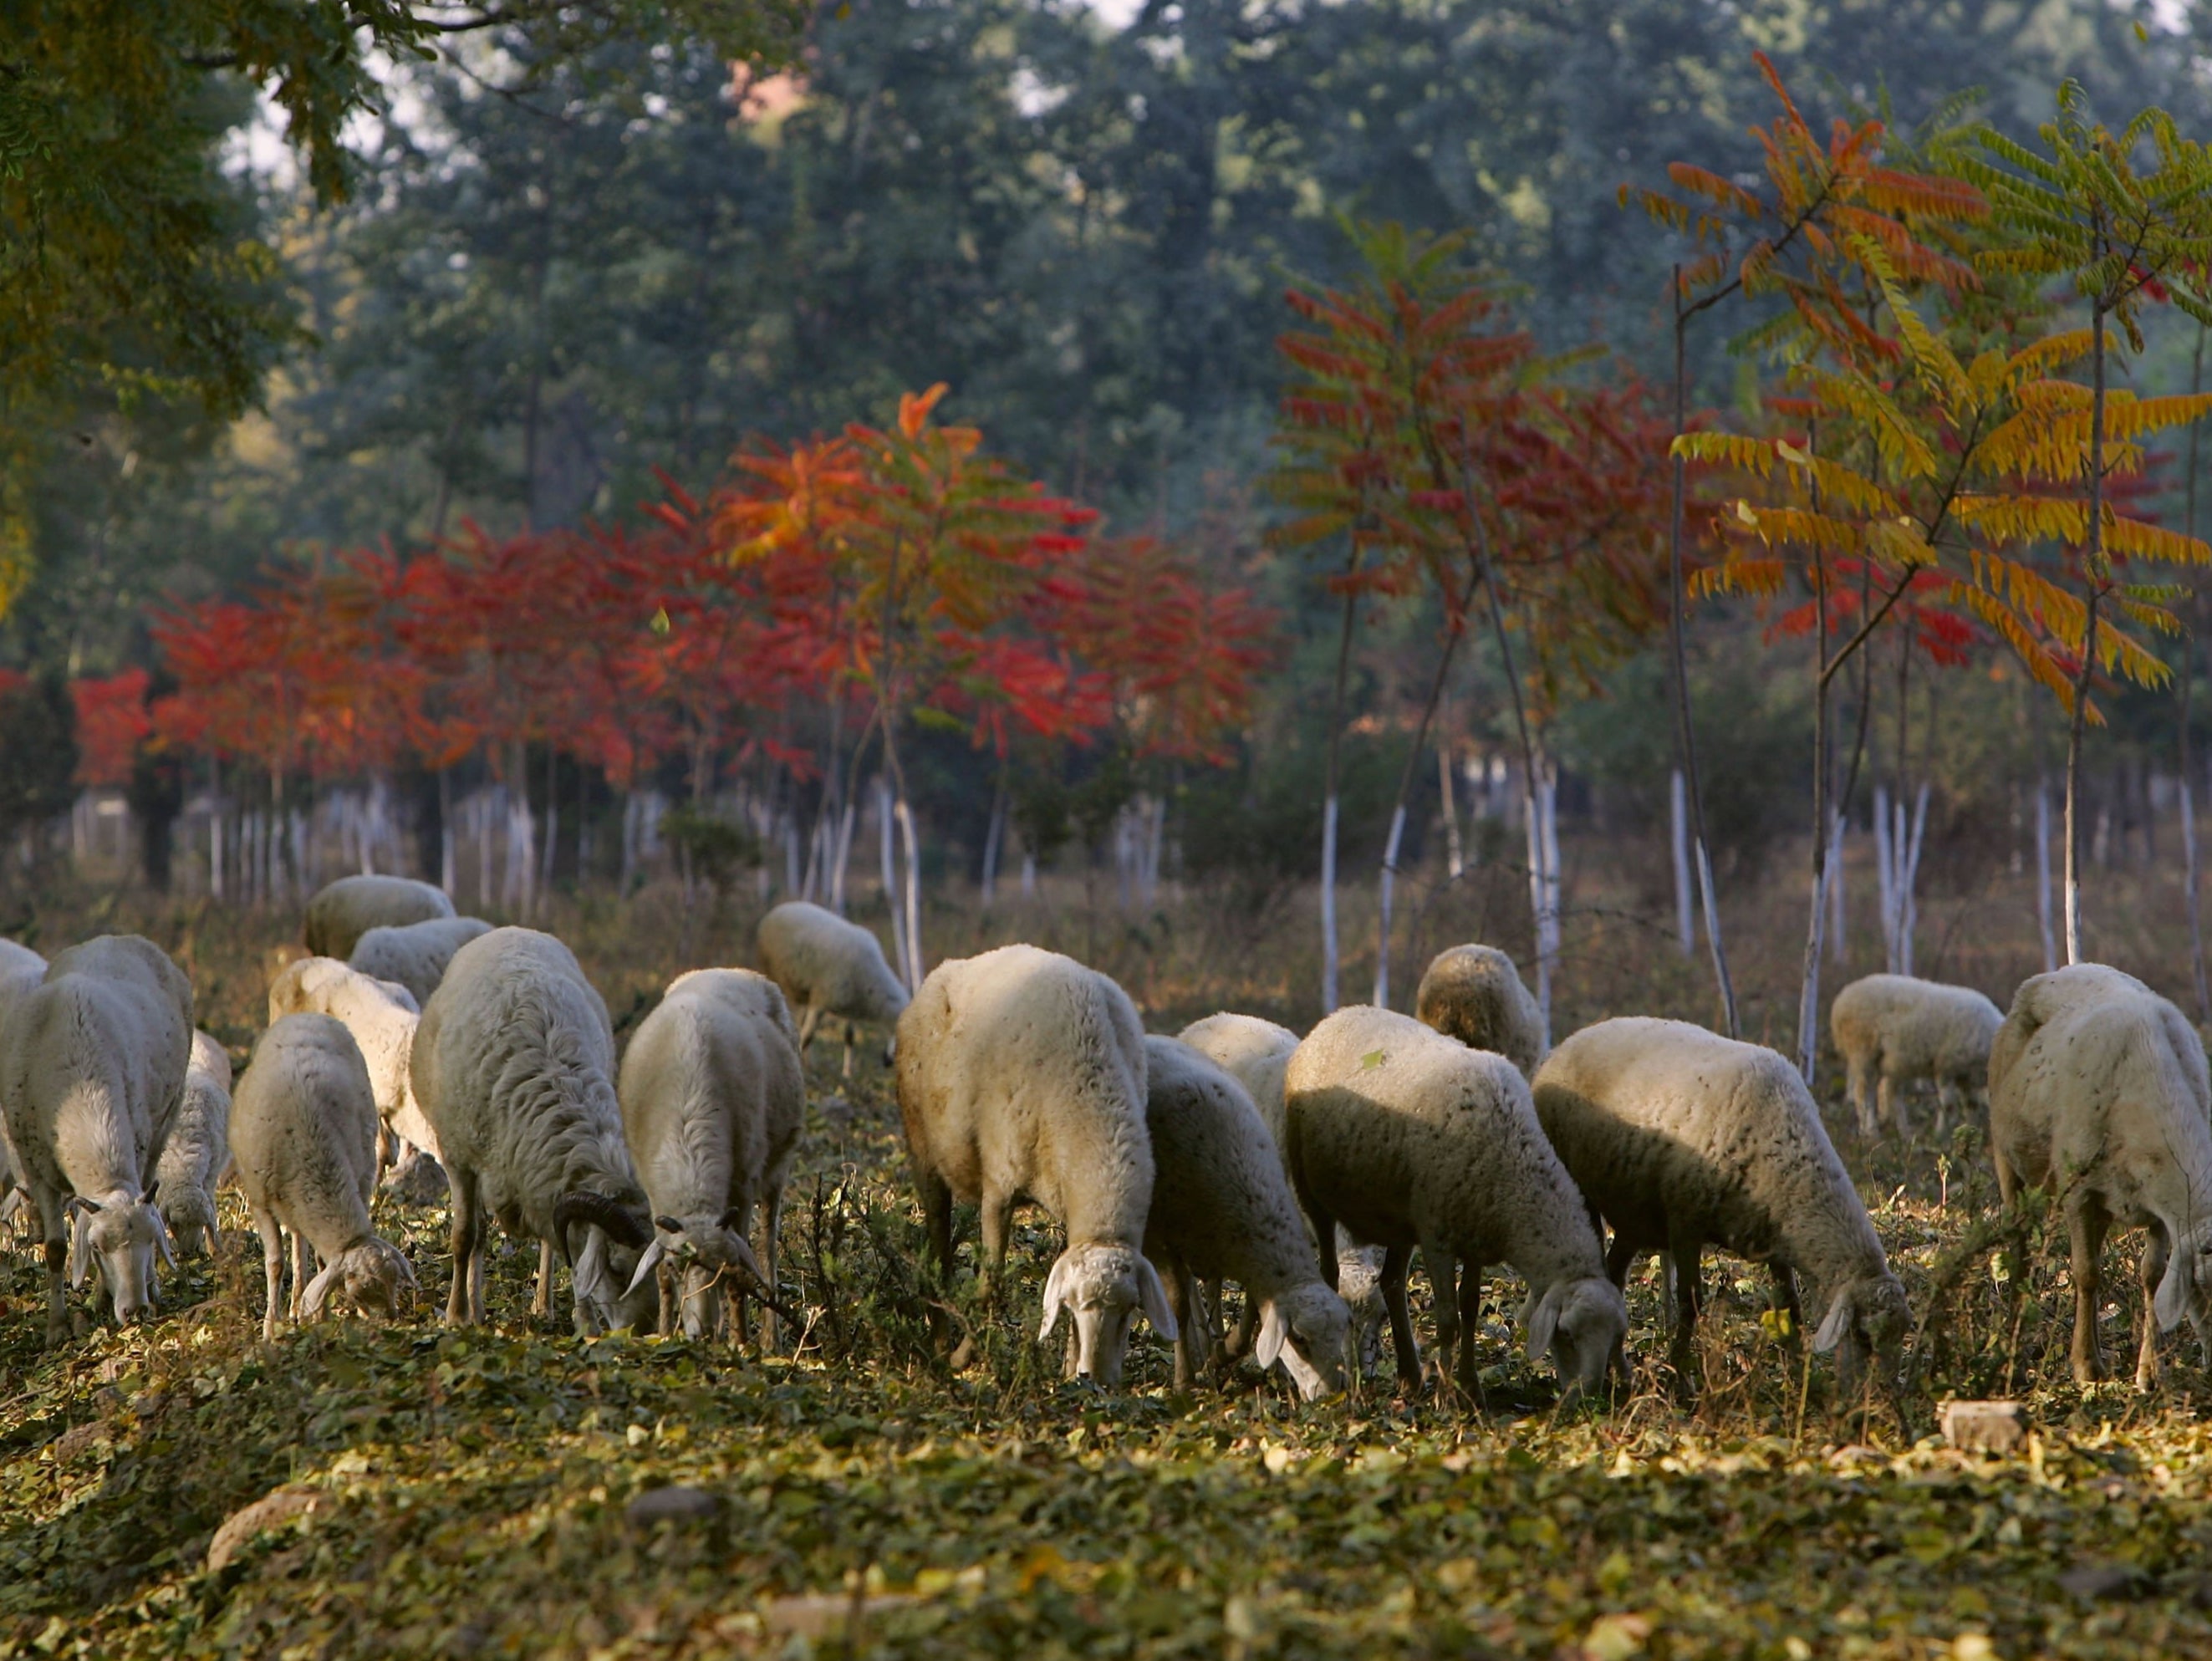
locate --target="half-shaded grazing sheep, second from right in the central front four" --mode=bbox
[1285,1004,1628,1396]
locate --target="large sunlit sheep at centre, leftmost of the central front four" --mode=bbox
[898,946,1179,1384]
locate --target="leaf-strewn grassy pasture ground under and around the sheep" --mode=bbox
[0,860,2212,1661]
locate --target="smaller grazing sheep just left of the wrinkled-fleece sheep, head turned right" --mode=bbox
[230,1013,415,1338]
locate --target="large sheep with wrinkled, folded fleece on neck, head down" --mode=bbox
[410,929,653,1336]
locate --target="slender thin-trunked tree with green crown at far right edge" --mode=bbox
[1960,79,2212,962]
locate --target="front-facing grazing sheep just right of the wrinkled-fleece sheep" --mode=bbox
[619,969,808,1343]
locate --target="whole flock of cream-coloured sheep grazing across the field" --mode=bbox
[0,878,2212,1400]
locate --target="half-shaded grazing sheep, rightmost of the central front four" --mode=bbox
[1535,1017,1909,1391]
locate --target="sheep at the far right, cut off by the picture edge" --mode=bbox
[1989,965,2212,1389]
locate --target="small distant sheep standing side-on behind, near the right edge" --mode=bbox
[1827,976,2004,1139]
